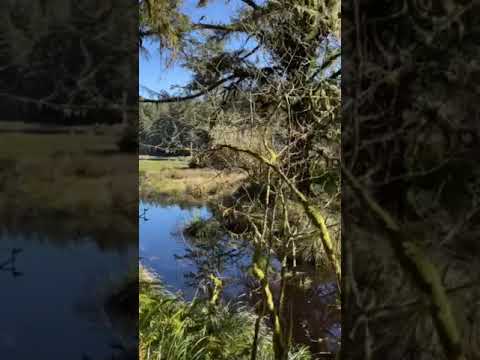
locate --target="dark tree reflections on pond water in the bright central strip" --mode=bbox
[176,221,341,355]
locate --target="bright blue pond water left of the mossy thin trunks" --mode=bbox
[139,202,251,300]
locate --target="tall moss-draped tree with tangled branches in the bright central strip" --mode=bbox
[142,0,341,360]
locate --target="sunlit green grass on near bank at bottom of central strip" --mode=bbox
[139,271,311,360]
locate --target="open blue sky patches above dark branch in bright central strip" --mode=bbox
[139,0,246,97]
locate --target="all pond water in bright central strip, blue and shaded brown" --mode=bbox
[139,198,341,354]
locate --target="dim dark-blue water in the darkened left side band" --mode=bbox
[0,230,138,360]
